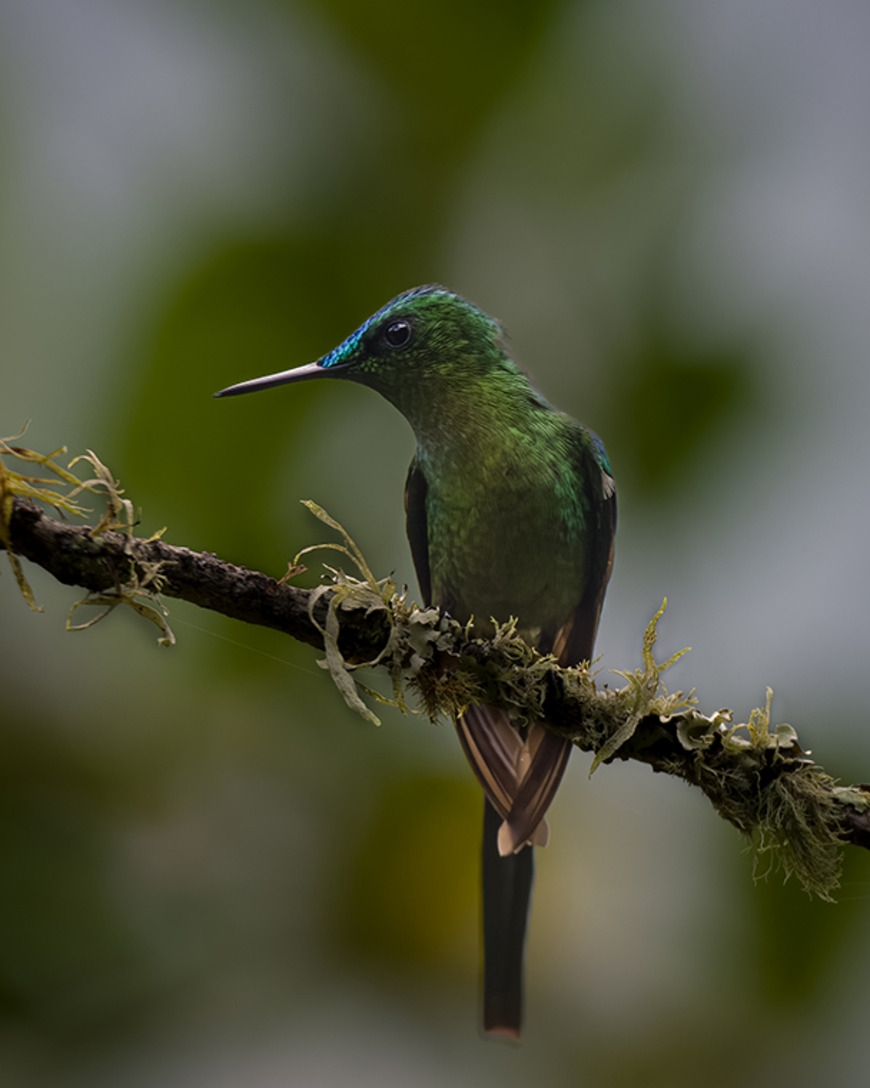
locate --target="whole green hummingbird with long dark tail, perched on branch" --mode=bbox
[215,285,617,1039]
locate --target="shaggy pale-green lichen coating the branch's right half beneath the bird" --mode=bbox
[300,511,867,900]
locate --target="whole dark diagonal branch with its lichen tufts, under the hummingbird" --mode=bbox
[0,443,870,899]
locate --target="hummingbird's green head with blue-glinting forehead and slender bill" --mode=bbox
[215,286,520,415]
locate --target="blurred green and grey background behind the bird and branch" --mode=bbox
[0,0,870,1088]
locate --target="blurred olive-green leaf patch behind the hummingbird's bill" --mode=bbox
[117,237,351,564]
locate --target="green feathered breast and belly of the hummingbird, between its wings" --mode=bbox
[418,412,588,642]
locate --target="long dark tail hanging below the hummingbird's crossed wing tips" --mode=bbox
[483,799,535,1039]
